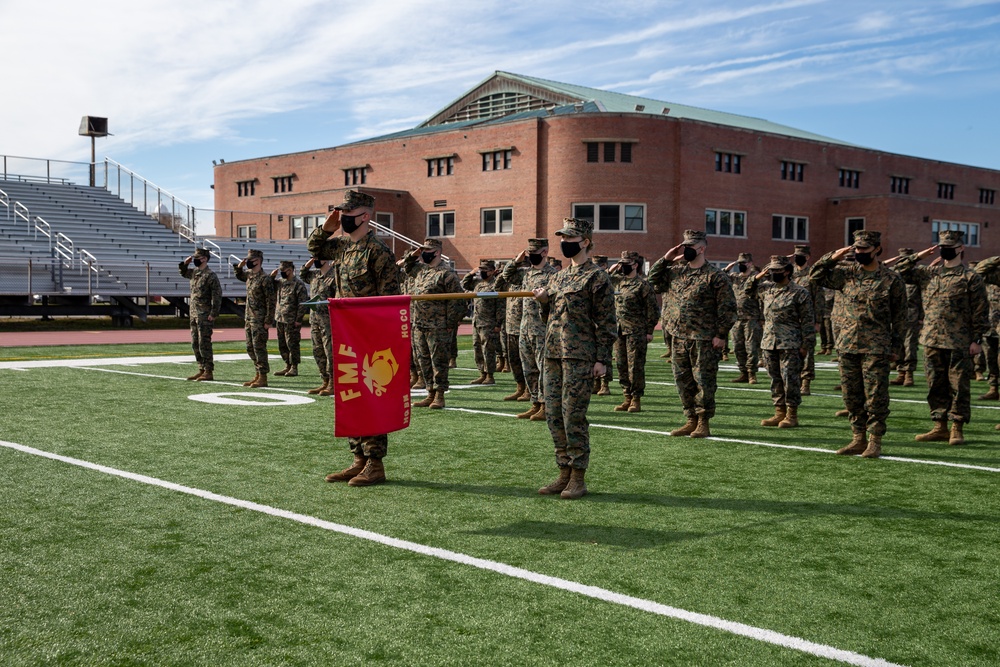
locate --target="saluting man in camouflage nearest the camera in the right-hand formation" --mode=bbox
[810,229,906,458]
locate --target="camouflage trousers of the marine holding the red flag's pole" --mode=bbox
[544,359,594,470]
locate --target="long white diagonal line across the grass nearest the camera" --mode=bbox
[0,440,902,667]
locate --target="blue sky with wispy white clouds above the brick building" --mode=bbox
[0,0,1000,234]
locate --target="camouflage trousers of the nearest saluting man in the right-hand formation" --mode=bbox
[840,352,892,435]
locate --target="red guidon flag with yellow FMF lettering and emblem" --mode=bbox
[329,295,410,438]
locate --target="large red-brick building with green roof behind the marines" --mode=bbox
[214,72,1000,269]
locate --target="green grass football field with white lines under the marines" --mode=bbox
[0,339,1000,666]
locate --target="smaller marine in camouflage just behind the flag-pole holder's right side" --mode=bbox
[609,250,660,412]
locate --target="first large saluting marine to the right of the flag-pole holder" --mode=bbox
[649,229,736,438]
